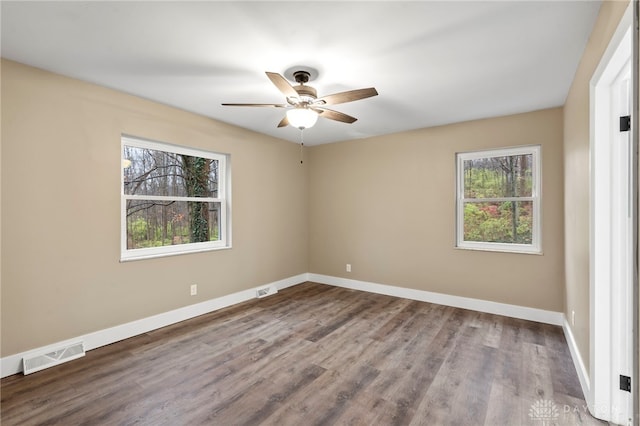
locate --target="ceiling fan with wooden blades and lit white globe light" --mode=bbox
[222,70,378,130]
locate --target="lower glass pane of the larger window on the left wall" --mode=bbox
[127,200,220,249]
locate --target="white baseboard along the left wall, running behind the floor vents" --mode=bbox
[0,273,308,377]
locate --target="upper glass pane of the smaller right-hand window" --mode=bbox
[464,154,533,198]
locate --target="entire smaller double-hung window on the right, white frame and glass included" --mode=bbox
[456,146,541,253]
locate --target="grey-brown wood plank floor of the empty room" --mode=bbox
[0,283,601,426]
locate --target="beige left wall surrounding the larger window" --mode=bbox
[1,61,308,356]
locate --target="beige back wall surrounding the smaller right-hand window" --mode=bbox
[309,108,564,311]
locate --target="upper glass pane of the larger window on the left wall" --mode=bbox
[122,145,218,198]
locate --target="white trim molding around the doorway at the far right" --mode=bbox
[583,2,637,421]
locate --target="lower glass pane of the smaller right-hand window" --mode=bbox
[464,201,533,244]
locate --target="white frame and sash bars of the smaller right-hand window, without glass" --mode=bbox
[456,145,542,254]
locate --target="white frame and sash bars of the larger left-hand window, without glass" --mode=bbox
[120,135,231,262]
